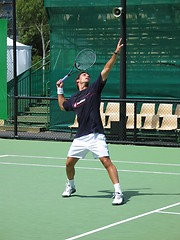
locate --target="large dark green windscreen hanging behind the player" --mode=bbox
[45,0,180,129]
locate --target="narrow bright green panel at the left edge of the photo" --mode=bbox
[0,19,7,120]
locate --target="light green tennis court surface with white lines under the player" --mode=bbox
[0,139,180,240]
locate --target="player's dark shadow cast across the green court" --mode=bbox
[72,188,180,203]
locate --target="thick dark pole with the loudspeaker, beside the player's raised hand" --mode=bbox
[119,0,126,141]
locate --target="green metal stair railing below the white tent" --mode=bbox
[7,55,50,122]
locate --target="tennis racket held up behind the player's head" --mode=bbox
[61,48,96,82]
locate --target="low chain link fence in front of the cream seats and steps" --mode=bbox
[0,97,180,146]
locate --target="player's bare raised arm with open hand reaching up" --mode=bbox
[101,38,123,81]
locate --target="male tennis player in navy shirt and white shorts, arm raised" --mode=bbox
[57,39,124,205]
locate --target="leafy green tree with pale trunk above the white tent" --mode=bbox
[16,0,50,66]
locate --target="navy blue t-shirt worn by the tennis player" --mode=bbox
[63,74,106,138]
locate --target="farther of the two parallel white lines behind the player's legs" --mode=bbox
[4,154,180,167]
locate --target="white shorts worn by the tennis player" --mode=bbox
[68,133,109,158]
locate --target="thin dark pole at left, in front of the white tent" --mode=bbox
[12,0,18,138]
